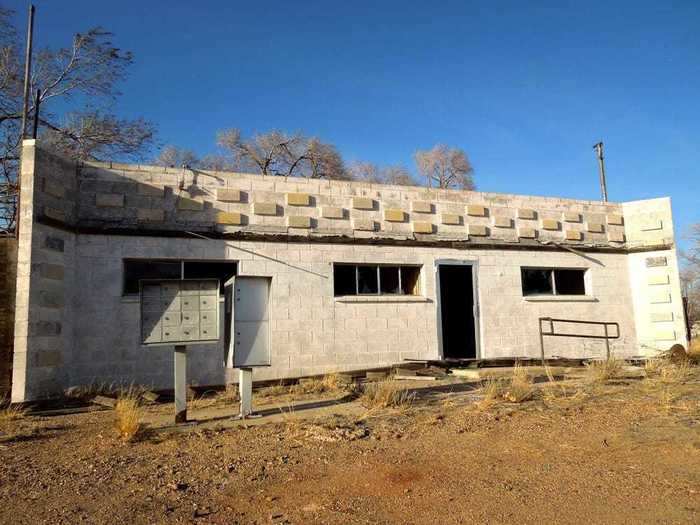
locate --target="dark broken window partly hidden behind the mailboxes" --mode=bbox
[123,259,237,295]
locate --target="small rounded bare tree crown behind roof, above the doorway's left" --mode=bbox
[414,144,476,190]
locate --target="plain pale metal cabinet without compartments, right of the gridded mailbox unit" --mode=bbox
[231,276,271,368]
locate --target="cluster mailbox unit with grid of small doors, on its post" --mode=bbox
[139,279,219,423]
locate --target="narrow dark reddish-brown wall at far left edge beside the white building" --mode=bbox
[0,237,17,399]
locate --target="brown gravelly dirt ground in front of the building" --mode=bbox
[0,371,700,524]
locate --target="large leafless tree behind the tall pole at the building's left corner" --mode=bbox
[0,9,155,230]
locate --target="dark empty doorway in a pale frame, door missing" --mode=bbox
[438,264,476,359]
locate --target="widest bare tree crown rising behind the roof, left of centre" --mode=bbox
[217,129,349,180]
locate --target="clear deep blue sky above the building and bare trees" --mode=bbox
[4,0,700,247]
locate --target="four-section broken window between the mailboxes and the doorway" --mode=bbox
[333,264,420,296]
